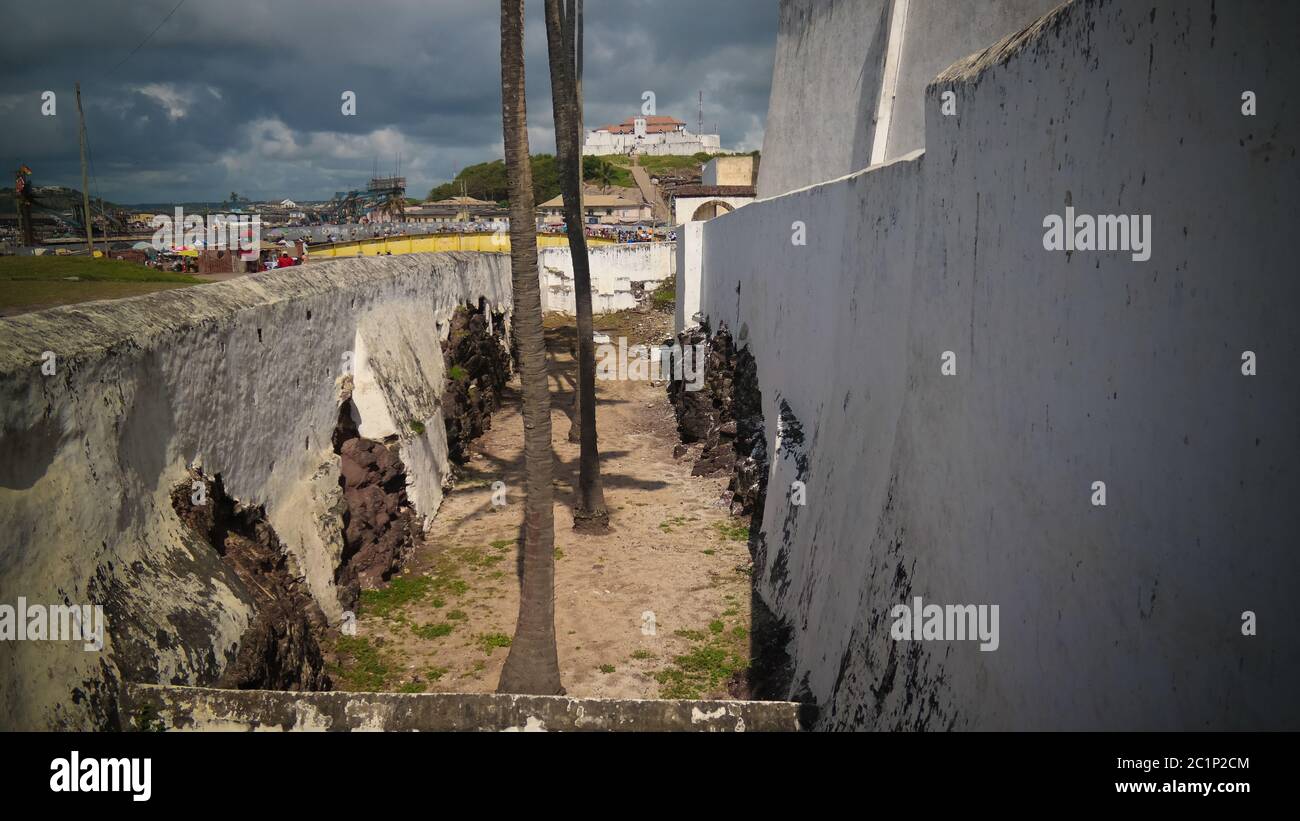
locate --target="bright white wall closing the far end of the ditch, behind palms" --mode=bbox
[537,243,676,314]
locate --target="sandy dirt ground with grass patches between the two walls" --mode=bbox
[332,312,751,698]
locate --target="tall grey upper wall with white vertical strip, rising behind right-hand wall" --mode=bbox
[758,0,1060,197]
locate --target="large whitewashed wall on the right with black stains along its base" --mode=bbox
[702,0,1300,729]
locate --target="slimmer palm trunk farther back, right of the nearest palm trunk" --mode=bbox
[546,0,610,530]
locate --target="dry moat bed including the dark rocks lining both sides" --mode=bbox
[173,301,790,699]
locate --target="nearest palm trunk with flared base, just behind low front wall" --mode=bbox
[497,0,563,695]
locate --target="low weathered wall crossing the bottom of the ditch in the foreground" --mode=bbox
[124,685,802,733]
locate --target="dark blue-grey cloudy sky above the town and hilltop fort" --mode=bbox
[0,0,777,203]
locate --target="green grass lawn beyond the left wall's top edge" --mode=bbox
[0,255,204,316]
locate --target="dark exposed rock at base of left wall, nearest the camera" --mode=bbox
[172,473,332,690]
